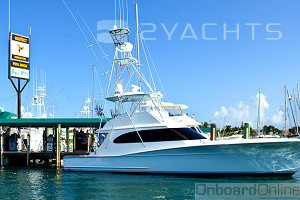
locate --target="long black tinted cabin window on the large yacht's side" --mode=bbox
[114,128,206,143]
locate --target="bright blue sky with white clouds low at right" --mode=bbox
[0,0,300,128]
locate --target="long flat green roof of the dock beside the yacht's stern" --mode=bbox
[0,118,110,128]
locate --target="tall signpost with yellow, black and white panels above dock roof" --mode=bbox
[8,32,30,118]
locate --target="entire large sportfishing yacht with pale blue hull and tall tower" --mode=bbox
[64,2,300,175]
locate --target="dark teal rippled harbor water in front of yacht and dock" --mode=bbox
[0,167,300,200]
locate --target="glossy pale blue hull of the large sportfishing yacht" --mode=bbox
[64,142,300,176]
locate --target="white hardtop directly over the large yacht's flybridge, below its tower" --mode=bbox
[106,92,162,102]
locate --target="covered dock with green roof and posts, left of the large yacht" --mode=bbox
[0,118,109,167]
